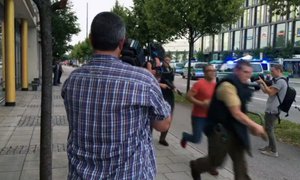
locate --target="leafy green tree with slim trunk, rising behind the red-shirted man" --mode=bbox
[144,0,244,91]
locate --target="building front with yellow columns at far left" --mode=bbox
[0,0,40,106]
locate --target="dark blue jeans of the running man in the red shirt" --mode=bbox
[182,116,207,143]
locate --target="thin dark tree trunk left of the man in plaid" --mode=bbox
[33,0,68,180]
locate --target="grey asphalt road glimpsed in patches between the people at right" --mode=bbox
[174,76,300,124]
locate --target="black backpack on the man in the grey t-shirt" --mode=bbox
[274,77,297,123]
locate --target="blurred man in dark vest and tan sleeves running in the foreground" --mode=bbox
[190,60,266,180]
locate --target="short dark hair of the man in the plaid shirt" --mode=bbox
[90,12,126,51]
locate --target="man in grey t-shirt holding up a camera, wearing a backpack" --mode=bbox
[257,64,288,157]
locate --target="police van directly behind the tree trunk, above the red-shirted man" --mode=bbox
[182,62,207,79]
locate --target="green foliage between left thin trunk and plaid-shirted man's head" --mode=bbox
[52,4,80,59]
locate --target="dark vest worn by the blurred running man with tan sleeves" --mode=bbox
[206,75,252,155]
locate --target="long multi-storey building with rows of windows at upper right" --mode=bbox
[196,0,300,59]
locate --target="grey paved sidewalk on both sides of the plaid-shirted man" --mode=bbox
[0,66,233,180]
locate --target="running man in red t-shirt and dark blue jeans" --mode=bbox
[180,64,219,175]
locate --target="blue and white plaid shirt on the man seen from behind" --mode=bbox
[62,55,170,180]
